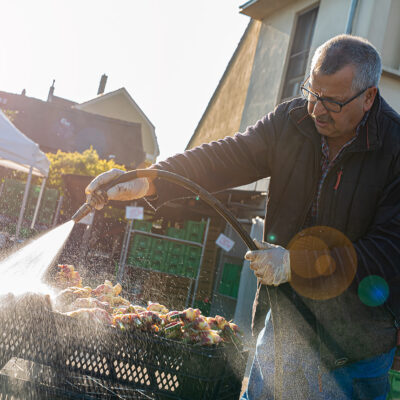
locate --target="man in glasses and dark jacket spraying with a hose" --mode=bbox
[87,35,400,400]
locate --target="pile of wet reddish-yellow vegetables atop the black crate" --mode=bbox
[55,264,242,346]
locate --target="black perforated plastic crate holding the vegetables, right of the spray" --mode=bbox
[54,314,247,400]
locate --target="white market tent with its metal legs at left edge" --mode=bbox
[0,110,50,239]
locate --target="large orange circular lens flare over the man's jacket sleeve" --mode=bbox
[287,226,357,300]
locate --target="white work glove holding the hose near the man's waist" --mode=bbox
[244,240,290,286]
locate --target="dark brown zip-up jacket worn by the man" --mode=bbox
[155,95,400,362]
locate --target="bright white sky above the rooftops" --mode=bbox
[0,0,250,160]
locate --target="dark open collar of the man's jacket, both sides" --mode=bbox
[289,91,382,152]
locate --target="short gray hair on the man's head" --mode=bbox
[311,35,382,90]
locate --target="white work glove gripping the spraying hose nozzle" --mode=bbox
[85,168,149,210]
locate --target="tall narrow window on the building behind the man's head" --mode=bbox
[281,7,318,100]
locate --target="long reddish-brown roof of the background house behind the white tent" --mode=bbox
[0,91,145,168]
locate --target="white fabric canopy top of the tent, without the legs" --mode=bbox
[0,110,50,177]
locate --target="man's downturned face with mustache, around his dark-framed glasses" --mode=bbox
[308,65,377,141]
